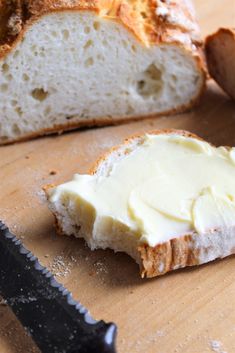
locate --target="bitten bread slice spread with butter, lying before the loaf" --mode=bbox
[46,130,235,277]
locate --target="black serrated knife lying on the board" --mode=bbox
[0,221,117,353]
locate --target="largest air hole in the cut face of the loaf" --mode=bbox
[137,64,163,98]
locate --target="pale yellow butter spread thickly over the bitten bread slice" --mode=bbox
[50,133,235,246]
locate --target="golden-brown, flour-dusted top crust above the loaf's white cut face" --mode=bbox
[0,0,201,57]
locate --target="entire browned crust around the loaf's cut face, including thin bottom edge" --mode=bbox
[0,0,206,144]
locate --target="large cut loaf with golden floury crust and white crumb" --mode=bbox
[0,0,205,144]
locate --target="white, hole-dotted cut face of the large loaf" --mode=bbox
[0,11,204,143]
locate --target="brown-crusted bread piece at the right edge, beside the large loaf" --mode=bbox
[205,28,235,100]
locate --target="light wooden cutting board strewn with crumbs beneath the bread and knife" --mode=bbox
[0,0,235,353]
